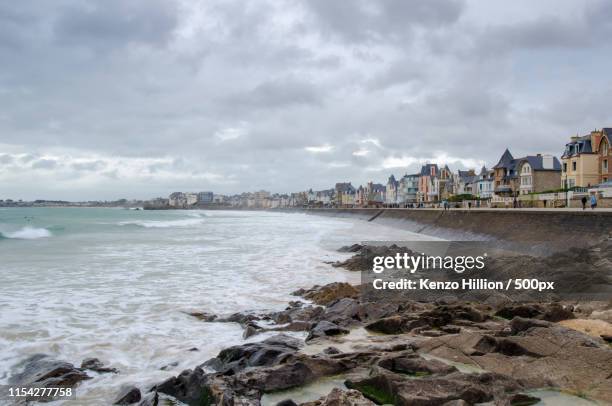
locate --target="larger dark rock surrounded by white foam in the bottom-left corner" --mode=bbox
[9,354,91,388]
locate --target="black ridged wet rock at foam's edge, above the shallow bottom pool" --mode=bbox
[203,334,303,373]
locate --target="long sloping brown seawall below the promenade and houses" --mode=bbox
[288,208,612,253]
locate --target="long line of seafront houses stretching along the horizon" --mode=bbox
[0,128,612,210]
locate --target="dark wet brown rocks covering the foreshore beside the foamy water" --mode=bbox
[11,241,612,406]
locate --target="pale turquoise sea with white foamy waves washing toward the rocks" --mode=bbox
[0,208,420,405]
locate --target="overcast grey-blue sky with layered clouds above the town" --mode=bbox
[0,0,612,200]
